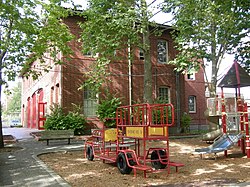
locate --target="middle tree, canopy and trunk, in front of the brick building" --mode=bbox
[80,0,162,103]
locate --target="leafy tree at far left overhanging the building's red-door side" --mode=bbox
[0,0,73,147]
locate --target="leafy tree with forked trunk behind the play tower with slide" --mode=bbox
[162,0,250,96]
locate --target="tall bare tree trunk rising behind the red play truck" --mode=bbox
[141,0,153,103]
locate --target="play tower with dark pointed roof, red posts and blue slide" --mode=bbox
[195,62,250,158]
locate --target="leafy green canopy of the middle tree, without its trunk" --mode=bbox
[79,0,138,91]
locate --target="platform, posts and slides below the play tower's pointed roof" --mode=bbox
[195,93,249,158]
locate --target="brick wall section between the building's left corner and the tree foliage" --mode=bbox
[61,16,94,112]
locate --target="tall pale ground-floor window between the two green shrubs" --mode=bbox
[83,87,98,117]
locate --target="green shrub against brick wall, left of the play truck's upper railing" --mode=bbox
[97,95,121,127]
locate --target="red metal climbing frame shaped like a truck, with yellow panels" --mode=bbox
[84,104,184,178]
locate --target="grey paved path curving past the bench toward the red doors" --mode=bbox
[0,128,83,187]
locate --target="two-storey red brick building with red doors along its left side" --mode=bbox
[22,16,206,131]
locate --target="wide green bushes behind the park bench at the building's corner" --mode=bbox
[44,104,87,135]
